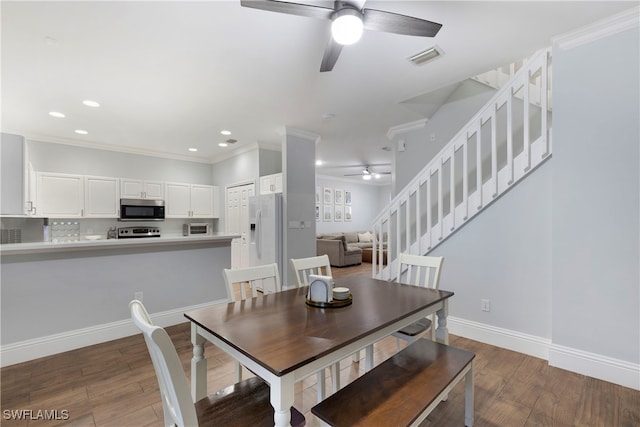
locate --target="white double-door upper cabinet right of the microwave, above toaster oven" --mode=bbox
[165,182,220,218]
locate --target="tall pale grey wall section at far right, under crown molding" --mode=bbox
[552,28,640,363]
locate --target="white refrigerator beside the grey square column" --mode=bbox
[249,193,286,293]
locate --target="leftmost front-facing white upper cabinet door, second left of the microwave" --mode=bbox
[35,172,84,218]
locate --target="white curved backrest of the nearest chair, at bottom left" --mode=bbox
[129,300,198,427]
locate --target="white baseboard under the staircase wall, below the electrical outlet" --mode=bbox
[447,316,551,360]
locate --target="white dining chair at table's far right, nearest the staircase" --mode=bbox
[393,253,444,350]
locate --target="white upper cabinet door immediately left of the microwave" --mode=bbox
[84,176,120,218]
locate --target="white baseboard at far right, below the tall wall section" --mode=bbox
[549,344,640,390]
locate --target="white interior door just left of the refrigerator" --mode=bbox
[225,183,255,268]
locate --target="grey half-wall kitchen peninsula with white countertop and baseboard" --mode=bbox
[0,233,239,366]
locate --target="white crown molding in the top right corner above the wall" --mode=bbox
[551,6,640,49]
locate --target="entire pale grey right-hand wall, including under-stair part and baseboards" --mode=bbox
[420,26,640,389]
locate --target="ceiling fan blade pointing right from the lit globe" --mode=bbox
[362,9,442,37]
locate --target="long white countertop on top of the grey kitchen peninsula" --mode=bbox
[0,233,240,255]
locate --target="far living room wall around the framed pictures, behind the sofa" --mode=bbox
[316,176,390,233]
